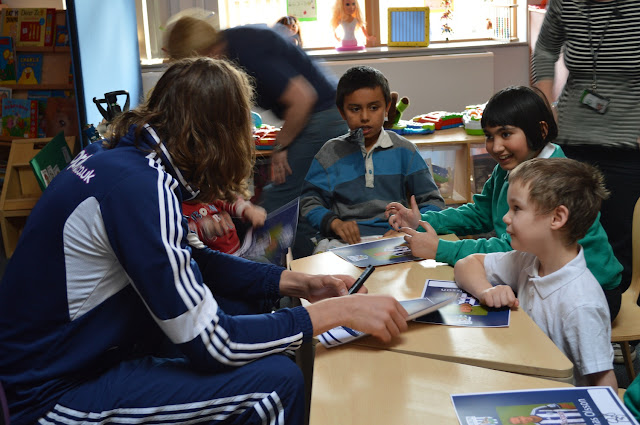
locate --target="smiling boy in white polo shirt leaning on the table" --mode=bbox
[454,158,618,391]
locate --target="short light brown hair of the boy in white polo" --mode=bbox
[509,158,609,244]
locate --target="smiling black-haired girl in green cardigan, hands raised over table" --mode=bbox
[386,86,622,320]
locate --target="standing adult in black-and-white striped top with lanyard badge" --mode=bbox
[532,0,640,291]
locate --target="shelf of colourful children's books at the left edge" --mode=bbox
[0,5,79,256]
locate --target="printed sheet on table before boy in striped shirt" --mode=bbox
[330,236,422,267]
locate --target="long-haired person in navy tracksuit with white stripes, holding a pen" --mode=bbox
[0,58,407,425]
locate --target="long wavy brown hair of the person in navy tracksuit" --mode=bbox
[109,57,255,202]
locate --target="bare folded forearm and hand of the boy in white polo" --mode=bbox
[453,254,520,308]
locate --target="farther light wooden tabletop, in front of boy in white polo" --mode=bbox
[291,248,573,378]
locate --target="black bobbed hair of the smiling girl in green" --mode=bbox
[480,86,558,151]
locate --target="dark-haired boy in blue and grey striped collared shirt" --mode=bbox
[300,66,444,253]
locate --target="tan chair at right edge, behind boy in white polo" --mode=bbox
[611,199,640,381]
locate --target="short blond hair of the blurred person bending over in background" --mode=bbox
[164,16,219,60]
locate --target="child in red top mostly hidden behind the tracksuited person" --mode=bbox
[182,198,267,254]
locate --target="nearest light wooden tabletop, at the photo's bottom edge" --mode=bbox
[309,344,571,425]
